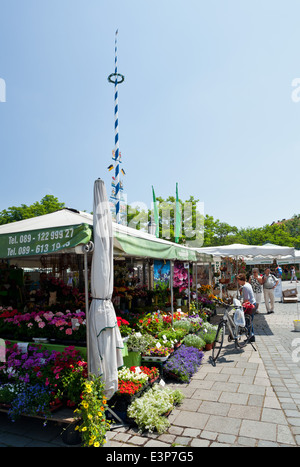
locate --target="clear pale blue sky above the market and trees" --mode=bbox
[0,0,300,227]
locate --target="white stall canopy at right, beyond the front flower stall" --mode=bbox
[198,243,295,258]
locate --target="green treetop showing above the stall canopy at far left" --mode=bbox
[0,195,65,225]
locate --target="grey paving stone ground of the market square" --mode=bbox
[0,283,300,449]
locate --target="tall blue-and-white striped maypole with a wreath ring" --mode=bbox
[108,30,125,224]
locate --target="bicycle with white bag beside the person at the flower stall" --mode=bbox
[212,299,256,363]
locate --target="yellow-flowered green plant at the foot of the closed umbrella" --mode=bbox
[74,376,110,447]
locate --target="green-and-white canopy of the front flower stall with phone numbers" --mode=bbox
[0,208,212,262]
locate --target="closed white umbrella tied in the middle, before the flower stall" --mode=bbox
[88,179,123,399]
